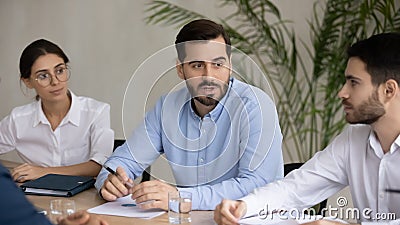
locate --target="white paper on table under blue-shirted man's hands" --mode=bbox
[87,195,165,219]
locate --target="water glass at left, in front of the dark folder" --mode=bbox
[49,199,76,224]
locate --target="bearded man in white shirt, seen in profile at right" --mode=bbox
[214,33,400,224]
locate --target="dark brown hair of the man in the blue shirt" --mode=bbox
[175,19,231,62]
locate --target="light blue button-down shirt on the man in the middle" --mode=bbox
[95,78,283,210]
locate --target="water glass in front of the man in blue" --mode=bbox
[168,191,192,224]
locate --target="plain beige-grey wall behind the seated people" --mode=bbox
[0,0,314,167]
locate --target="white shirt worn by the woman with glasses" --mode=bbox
[0,92,114,167]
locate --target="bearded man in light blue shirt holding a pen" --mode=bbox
[95,19,283,210]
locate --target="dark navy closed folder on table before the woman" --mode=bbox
[20,174,95,197]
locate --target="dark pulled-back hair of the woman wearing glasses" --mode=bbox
[19,39,69,78]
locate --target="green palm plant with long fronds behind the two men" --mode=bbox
[146,0,400,162]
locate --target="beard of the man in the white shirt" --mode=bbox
[343,90,386,124]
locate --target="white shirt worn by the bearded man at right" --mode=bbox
[241,125,400,224]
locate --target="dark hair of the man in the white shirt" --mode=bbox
[347,33,400,85]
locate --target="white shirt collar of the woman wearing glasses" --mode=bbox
[33,90,81,127]
